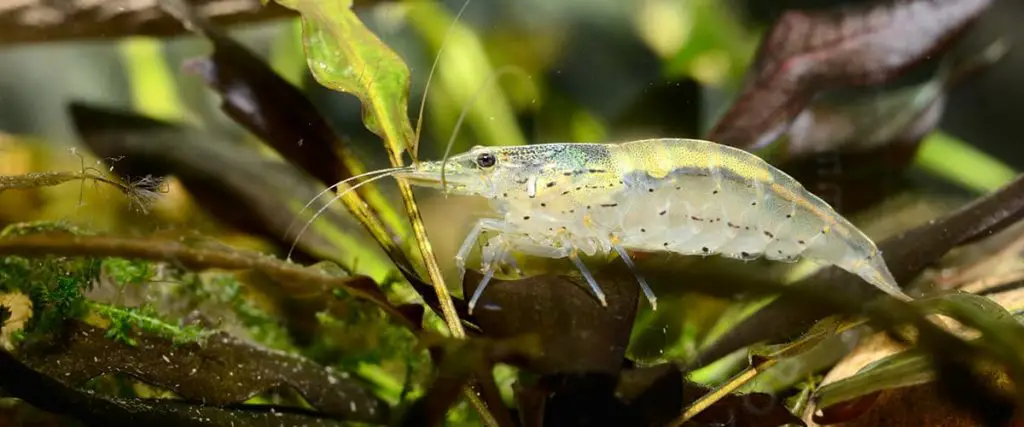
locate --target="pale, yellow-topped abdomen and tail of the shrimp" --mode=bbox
[615,139,907,299]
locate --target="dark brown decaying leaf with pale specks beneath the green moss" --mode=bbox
[20,323,388,422]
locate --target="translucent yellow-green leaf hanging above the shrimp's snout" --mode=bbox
[278,0,417,159]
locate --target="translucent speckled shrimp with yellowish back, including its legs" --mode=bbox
[394,139,909,309]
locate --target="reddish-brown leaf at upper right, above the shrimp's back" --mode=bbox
[709,0,991,150]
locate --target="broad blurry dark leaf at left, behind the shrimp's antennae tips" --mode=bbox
[69,102,373,265]
